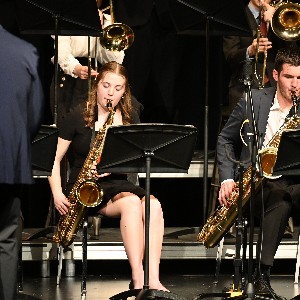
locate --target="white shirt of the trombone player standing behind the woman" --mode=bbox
[51,14,125,78]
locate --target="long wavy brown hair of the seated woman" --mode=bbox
[83,61,132,128]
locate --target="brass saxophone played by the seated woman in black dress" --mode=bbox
[53,101,115,247]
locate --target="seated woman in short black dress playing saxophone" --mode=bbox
[49,62,167,291]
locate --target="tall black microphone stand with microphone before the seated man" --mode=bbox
[243,59,263,299]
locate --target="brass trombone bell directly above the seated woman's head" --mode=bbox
[100,0,134,51]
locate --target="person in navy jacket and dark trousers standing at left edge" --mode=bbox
[0,25,44,300]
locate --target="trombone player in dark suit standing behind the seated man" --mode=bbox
[223,0,283,116]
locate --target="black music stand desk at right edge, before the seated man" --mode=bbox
[273,129,300,176]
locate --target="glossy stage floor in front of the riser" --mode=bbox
[20,260,300,300]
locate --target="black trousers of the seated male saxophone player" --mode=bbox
[254,178,300,266]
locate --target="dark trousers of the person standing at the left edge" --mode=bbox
[0,184,21,300]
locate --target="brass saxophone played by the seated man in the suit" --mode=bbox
[197,92,300,248]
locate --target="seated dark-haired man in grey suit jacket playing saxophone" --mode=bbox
[217,46,300,299]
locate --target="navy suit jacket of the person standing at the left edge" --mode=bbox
[0,25,44,184]
